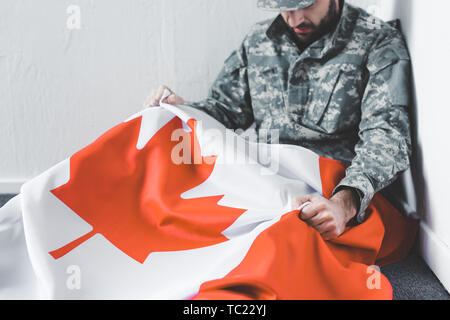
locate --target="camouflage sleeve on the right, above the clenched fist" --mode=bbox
[333,32,411,223]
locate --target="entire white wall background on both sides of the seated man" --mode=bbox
[0,0,450,288]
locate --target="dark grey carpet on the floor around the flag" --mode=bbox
[0,195,450,300]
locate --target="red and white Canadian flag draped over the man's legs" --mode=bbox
[0,92,414,300]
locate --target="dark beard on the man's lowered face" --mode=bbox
[286,0,341,49]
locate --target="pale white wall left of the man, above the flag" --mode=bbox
[0,0,274,188]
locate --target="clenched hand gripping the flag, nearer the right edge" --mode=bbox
[294,189,357,240]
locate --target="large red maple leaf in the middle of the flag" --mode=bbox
[50,117,246,263]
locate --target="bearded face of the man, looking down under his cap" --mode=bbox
[281,0,339,45]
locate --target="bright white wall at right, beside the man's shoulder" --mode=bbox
[390,0,450,291]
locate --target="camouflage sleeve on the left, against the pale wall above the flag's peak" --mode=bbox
[185,41,254,130]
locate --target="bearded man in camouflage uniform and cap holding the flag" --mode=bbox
[148,0,411,240]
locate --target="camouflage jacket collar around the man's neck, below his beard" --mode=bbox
[266,2,359,58]
